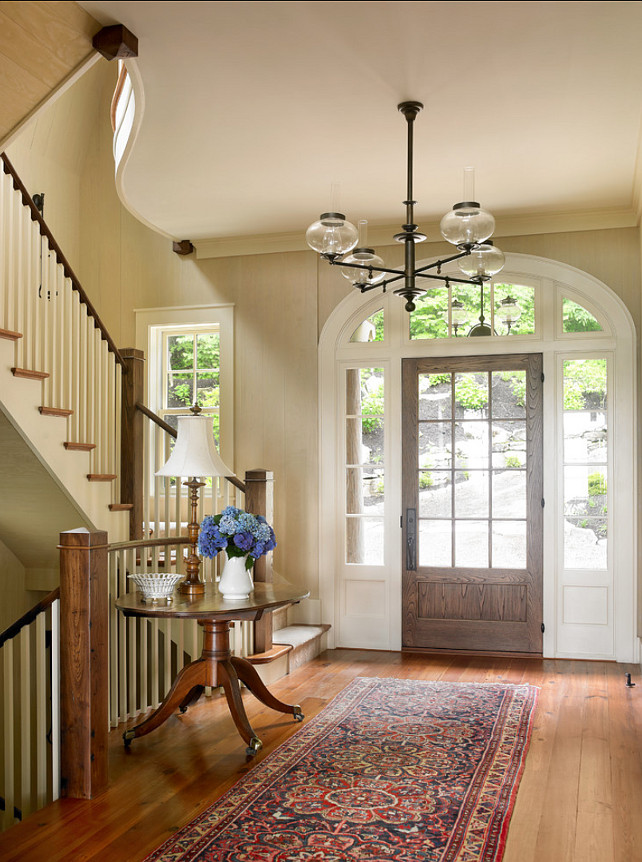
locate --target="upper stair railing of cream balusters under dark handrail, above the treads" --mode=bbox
[0,153,124,501]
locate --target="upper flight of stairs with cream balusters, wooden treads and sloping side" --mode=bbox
[0,154,128,538]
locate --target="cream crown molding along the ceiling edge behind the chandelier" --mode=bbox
[193,207,640,260]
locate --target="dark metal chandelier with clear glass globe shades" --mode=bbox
[306,102,504,316]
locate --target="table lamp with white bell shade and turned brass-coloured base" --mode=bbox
[156,404,234,597]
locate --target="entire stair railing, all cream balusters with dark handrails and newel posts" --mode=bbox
[0,154,280,828]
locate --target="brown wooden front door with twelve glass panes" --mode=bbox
[402,354,543,655]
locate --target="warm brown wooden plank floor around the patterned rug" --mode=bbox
[0,650,642,862]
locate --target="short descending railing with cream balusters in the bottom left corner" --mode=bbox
[0,589,60,829]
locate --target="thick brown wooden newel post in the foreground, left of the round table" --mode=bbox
[58,529,109,799]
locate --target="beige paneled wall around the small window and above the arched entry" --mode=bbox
[6,63,641,616]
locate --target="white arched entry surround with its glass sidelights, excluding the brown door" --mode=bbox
[319,254,637,661]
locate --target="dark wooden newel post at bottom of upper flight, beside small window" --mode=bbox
[120,347,145,540]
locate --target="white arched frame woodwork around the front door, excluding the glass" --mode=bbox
[318,254,639,662]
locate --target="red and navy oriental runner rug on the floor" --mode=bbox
[146,678,537,862]
